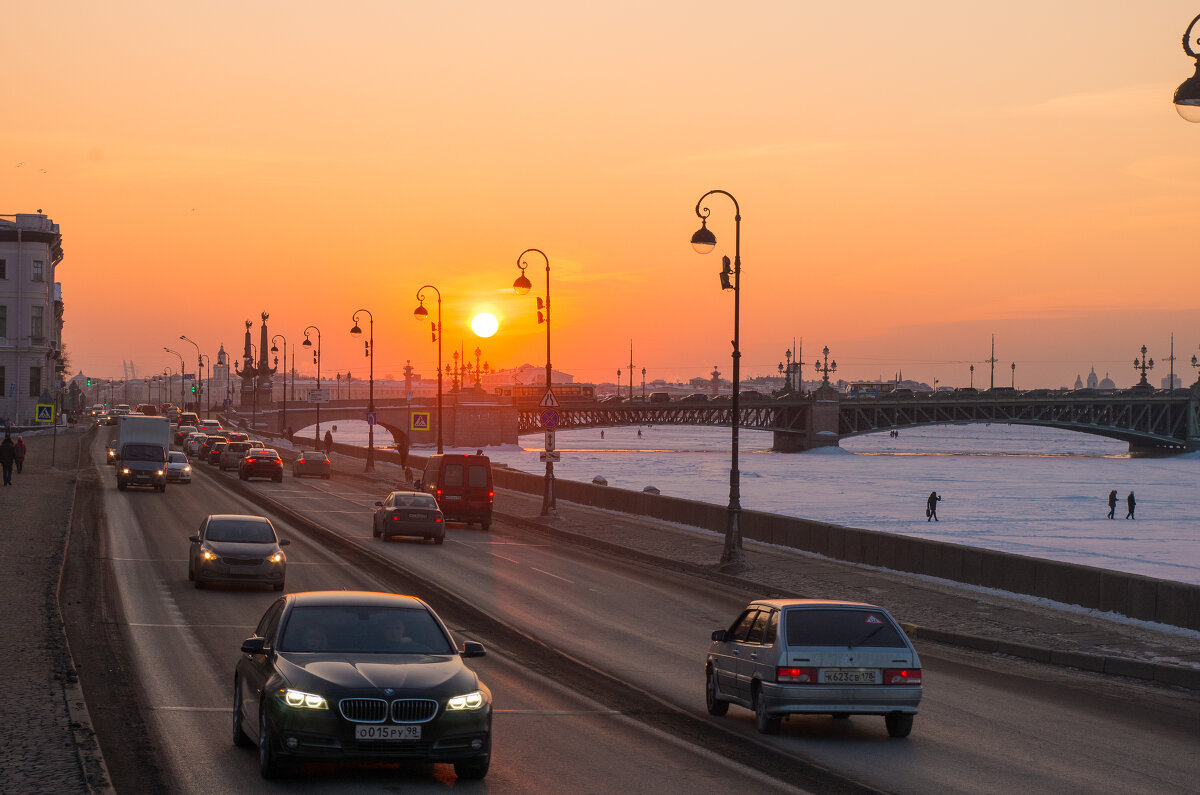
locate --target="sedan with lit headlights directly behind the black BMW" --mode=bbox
[187,514,290,591]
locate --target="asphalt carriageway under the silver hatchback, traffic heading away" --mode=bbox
[218,451,1200,793]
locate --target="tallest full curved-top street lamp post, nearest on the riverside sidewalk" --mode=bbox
[691,190,751,572]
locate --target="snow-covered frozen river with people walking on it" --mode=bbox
[304,422,1200,584]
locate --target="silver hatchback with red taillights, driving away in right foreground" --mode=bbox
[704,599,922,737]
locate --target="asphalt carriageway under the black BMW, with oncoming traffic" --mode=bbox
[92,435,796,793]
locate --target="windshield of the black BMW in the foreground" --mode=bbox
[278,605,455,654]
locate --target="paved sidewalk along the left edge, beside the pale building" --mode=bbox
[0,428,108,793]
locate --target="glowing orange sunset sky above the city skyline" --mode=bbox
[9,0,1200,387]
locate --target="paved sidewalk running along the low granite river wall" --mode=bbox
[304,439,1200,692]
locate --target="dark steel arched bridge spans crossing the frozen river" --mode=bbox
[517,388,1200,454]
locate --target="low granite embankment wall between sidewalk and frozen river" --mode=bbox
[304,432,1200,629]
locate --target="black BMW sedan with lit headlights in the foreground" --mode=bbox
[233,591,492,778]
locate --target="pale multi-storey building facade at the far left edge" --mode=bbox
[0,210,64,425]
